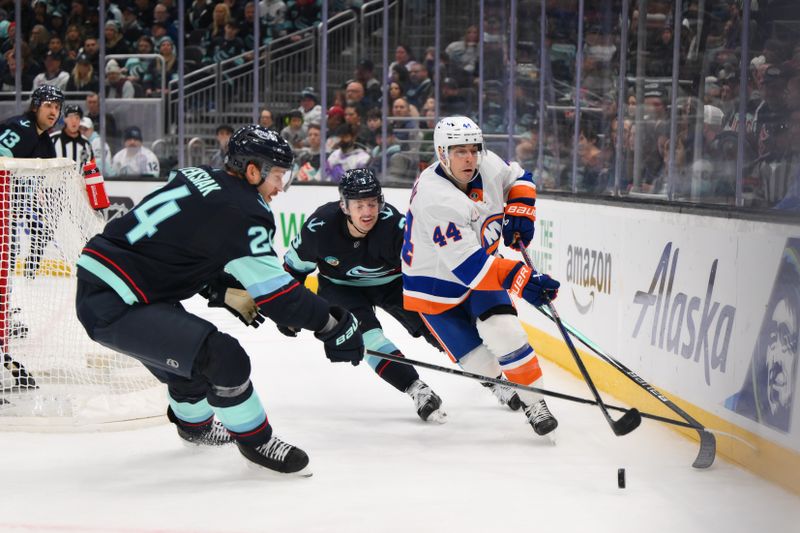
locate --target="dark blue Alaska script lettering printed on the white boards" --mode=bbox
[633,242,736,385]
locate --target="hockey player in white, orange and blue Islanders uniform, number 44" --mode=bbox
[402,117,559,435]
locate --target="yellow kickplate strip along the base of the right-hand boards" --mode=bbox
[522,322,800,495]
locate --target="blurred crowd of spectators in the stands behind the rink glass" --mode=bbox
[0,0,800,209]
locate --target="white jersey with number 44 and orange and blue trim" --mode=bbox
[402,150,536,314]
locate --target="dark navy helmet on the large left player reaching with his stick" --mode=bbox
[225,124,294,190]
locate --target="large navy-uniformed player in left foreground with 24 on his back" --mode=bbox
[76,126,364,474]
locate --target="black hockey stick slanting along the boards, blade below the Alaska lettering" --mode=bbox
[537,308,717,468]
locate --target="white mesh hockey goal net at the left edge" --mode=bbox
[0,158,166,430]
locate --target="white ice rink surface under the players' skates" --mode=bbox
[0,302,800,533]
